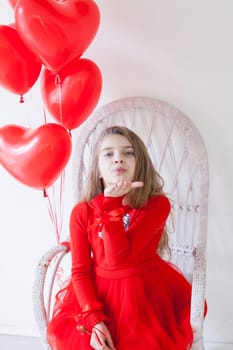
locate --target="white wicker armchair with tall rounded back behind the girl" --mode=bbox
[33,97,209,350]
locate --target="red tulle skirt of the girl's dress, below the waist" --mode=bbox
[48,259,193,350]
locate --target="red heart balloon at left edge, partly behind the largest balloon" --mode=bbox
[0,25,42,95]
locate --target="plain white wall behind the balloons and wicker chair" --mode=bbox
[0,0,233,342]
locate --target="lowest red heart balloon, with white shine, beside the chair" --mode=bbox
[0,123,71,189]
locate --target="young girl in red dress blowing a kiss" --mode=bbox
[48,126,193,350]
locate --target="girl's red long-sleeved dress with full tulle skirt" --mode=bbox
[48,194,193,350]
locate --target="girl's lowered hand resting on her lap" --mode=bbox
[90,322,116,350]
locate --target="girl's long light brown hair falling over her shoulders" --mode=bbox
[82,126,169,254]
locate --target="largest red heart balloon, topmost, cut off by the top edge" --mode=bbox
[15,0,100,71]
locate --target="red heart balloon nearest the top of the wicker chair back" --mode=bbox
[41,59,102,130]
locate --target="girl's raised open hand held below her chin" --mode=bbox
[104,181,144,197]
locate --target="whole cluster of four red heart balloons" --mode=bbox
[0,0,102,192]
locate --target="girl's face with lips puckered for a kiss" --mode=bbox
[98,134,136,187]
